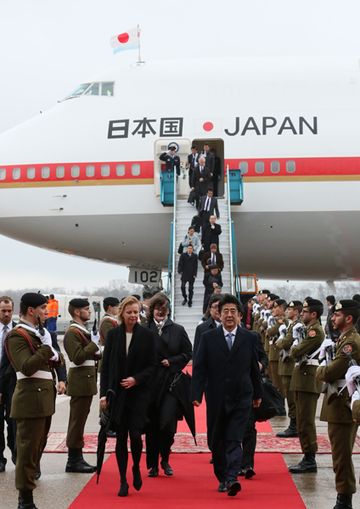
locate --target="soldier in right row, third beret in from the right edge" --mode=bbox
[275,300,304,438]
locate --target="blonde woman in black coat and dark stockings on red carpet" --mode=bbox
[100,296,156,497]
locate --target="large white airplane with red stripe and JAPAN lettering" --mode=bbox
[0,57,360,281]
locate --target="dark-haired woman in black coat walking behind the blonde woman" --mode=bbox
[146,293,192,477]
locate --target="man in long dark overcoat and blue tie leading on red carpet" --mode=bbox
[191,294,262,496]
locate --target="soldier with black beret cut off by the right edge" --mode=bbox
[316,299,360,509]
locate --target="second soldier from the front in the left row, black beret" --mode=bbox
[64,299,101,474]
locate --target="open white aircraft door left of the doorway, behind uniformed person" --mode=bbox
[154,138,191,198]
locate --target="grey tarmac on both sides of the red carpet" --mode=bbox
[0,340,360,509]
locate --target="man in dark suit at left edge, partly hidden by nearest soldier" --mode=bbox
[0,296,16,472]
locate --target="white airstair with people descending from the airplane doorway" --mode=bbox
[167,170,242,342]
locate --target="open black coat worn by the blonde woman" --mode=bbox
[100,324,156,431]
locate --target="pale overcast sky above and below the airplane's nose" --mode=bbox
[0,0,360,289]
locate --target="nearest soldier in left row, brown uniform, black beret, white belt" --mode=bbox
[5,293,63,509]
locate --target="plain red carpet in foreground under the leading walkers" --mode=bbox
[70,454,305,509]
